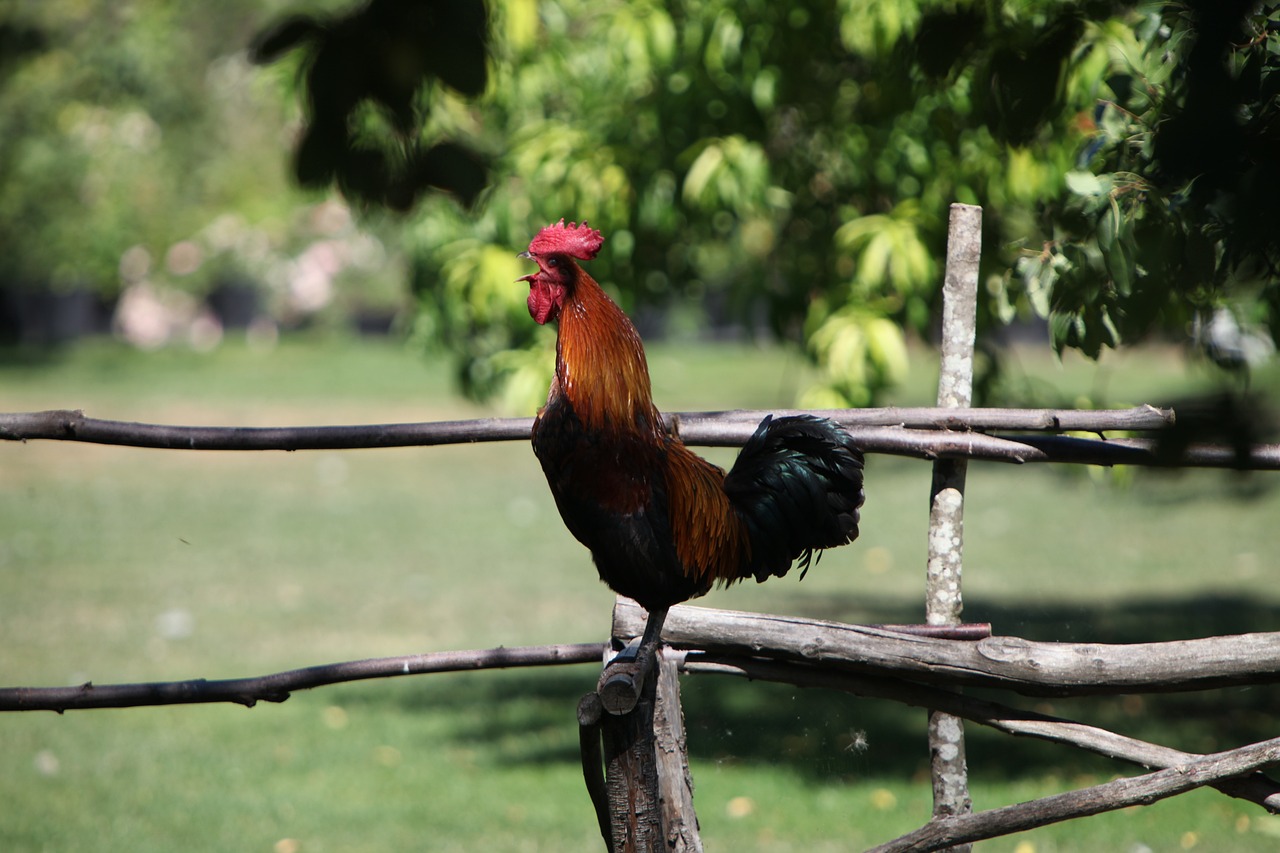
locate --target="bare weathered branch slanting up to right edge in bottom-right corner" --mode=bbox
[870,738,1280,853]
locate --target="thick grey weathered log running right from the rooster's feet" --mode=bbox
[613,599,1280,695]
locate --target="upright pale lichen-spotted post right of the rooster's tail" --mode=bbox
[925,204,982,850]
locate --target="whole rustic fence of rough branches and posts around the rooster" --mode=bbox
[0,205,1280,852]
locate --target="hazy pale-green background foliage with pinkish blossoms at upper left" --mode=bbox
[0,0,403,346]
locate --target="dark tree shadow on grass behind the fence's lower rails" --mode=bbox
[343,597,1280,781]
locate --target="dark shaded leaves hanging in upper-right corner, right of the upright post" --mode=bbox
[1000,1,1280,368]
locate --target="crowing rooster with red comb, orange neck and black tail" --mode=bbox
[517,219,863,649]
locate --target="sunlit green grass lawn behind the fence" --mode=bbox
[0,339,1280,853]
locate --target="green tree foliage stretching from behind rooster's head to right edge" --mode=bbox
[401,0,1280,406]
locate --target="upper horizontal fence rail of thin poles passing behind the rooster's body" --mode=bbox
[0,406,1280,470]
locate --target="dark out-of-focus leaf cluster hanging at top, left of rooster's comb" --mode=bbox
[250,0,489,211]
